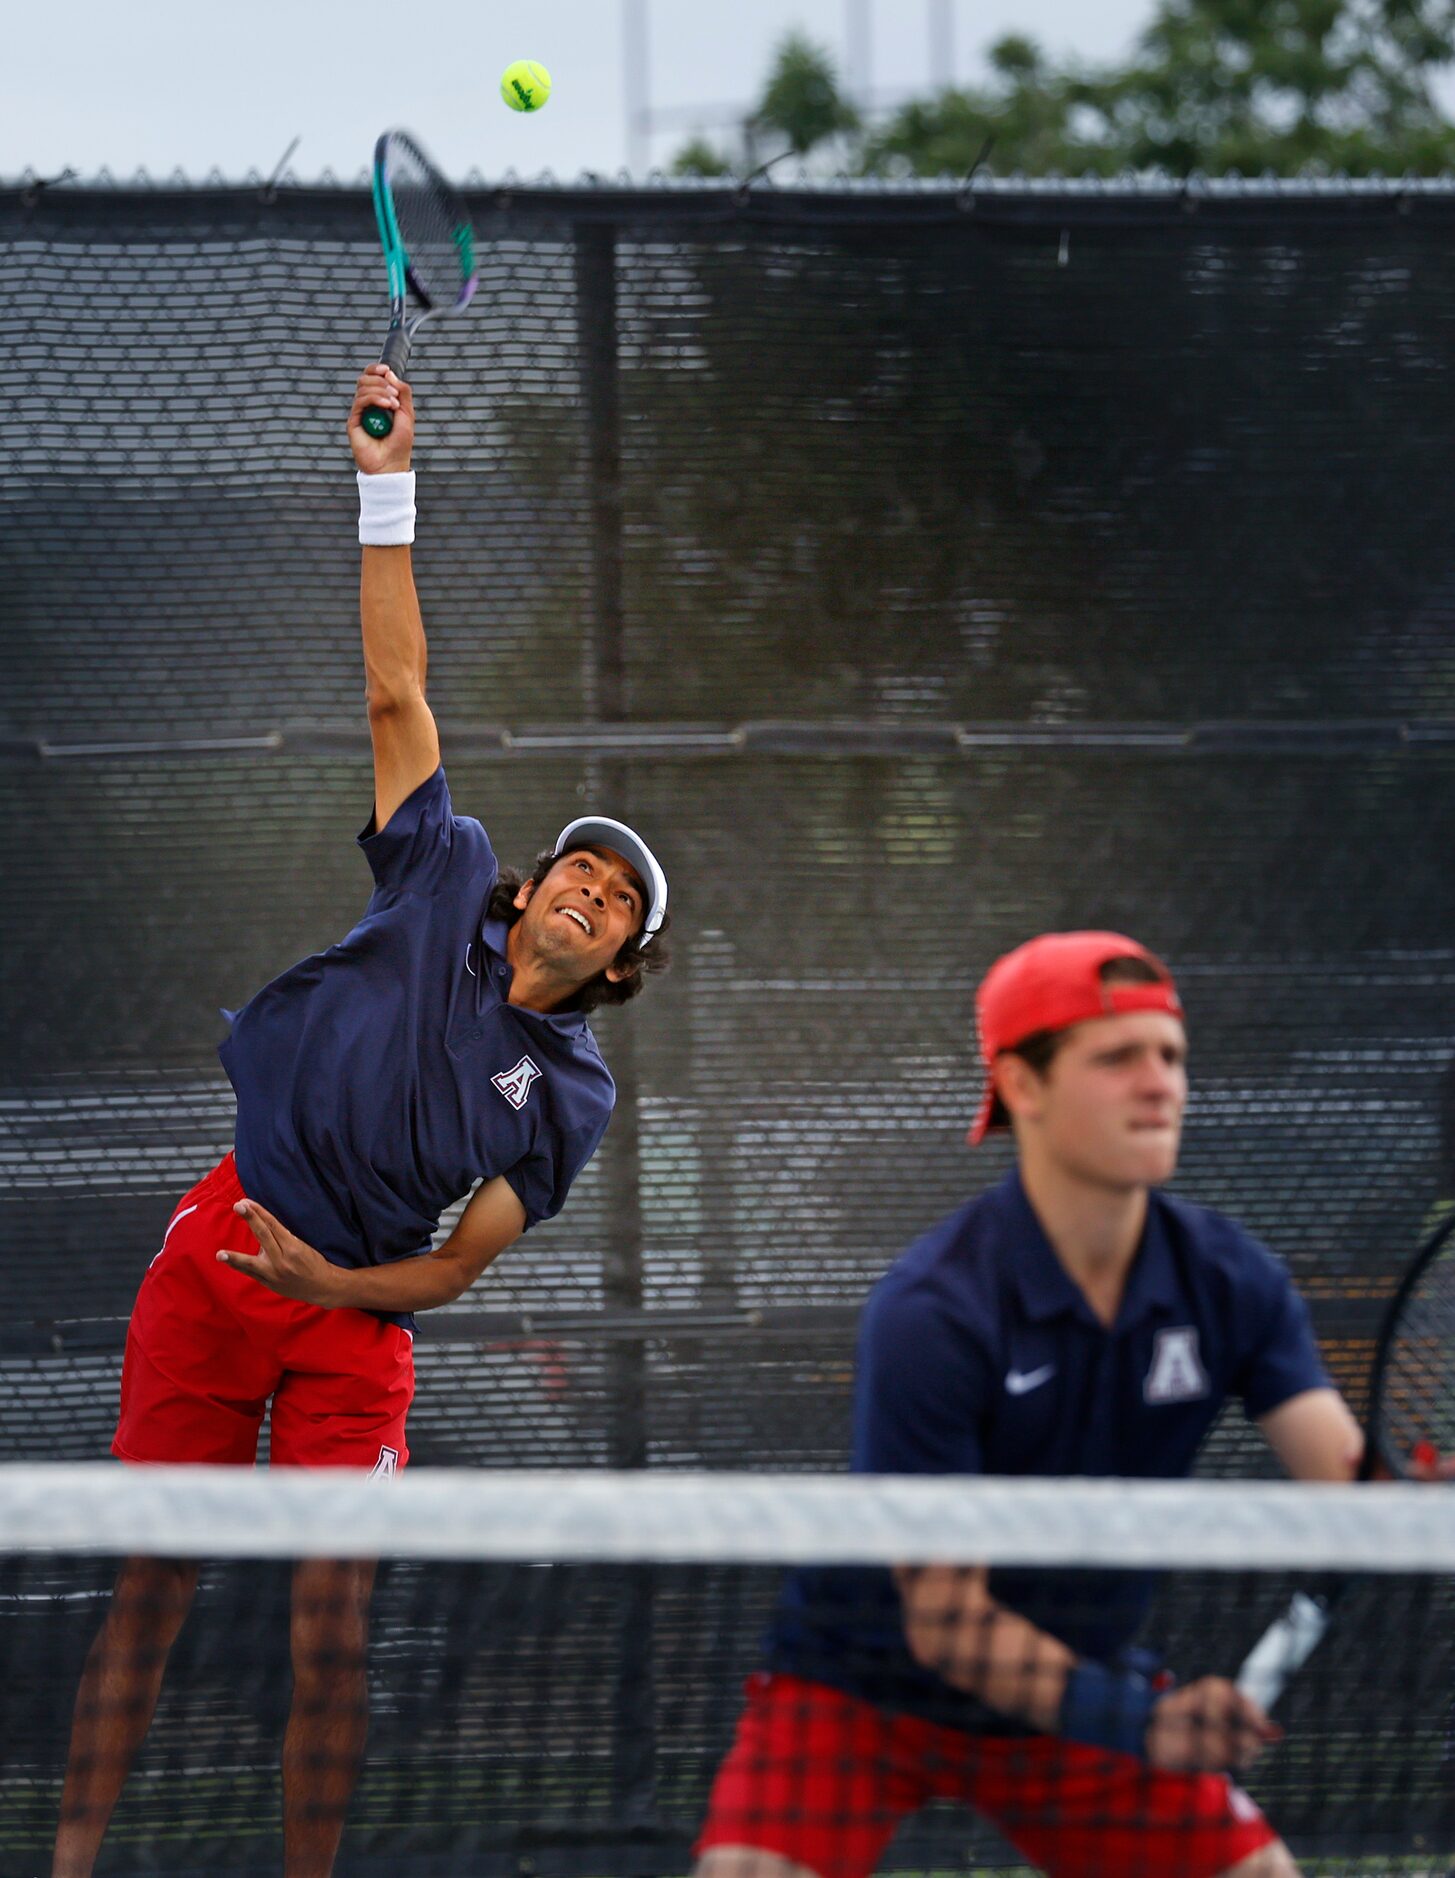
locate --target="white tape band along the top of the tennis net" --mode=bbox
[0,1465,1455,1572]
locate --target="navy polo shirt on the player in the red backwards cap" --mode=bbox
[770,1172,1329,1733]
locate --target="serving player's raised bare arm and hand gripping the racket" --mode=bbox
[349,364,439,828]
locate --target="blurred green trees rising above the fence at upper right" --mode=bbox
[680,0,1455,177]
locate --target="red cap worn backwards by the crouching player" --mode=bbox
[969,933,1183,1146]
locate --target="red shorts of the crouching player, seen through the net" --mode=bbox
[697,1675,1277,1878]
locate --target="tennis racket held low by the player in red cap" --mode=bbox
[1237,1208,1455,1711]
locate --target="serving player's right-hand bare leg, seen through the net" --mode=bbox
[283,1559,374,1878]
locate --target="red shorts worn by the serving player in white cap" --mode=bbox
[111,1155,415,1474]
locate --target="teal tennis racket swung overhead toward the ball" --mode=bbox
[364,130,479,438]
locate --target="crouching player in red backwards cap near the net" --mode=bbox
[697,931,1361,1878]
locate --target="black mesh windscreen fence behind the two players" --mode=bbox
[0,188,1455,1872]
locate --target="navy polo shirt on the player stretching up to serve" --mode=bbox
[220,768,616,1324]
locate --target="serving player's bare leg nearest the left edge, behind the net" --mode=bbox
[51,1559,197,1878]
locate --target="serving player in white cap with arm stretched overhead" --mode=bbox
[53,364,668,1878]
